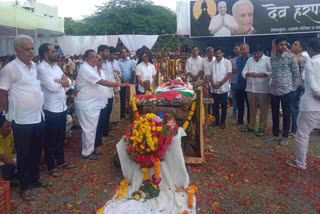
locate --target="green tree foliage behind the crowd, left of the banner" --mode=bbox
[65,0,176,35]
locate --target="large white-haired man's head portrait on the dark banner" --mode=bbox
[232,0,256,35]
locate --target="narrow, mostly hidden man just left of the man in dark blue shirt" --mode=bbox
[230,43,241,118]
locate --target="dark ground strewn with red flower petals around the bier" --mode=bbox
[6,110,320,214]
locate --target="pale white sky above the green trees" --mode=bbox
[36,0,176,20]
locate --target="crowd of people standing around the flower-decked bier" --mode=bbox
[0,35,320,200]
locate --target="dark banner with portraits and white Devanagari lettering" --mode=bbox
[189,0,320,37]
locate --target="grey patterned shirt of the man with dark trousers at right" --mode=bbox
[270,52,300,96]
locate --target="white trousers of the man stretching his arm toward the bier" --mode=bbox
[77,109,100,156]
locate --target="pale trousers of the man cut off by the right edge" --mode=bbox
[296,111,320,168]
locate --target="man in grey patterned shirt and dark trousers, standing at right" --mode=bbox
[270,36,300,145]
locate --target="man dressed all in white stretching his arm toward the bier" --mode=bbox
[75,49,127,160]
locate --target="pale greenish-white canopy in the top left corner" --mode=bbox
[0,2,64,37]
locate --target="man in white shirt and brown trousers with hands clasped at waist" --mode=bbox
[242,45,271,136]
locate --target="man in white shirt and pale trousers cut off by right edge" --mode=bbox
[287,38,320,169]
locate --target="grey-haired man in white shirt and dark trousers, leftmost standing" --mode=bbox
[0,35,52,200]
